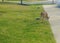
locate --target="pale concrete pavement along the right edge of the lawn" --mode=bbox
[43,5,60,43]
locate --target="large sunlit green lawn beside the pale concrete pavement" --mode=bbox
[0,4,55,43]
